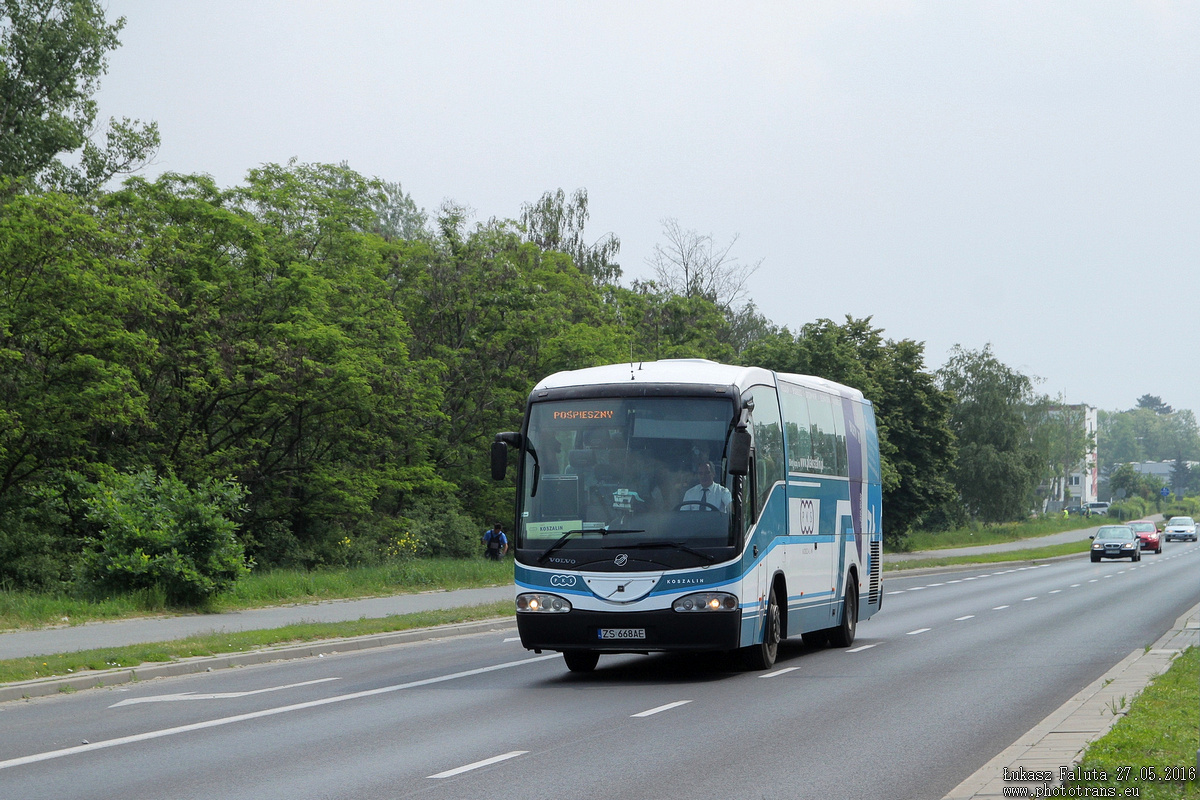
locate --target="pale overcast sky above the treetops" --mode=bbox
[98,0,1200,413]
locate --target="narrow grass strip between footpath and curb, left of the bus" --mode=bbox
[0,601,514,684]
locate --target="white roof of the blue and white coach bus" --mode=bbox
[534,359,863,401]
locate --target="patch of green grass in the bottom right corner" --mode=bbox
[1068,648,1200,800]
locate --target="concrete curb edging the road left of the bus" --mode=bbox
[0,618,516,703]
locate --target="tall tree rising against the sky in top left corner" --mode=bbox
[0,0,158,193]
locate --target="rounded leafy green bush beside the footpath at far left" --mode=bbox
[79,470,250,606]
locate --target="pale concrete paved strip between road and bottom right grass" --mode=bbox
[943,604,1200,800]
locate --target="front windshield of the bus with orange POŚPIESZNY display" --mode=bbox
[517,397,739,569]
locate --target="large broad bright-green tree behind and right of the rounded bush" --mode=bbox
[103,163,442,565]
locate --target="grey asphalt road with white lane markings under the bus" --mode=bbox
[0,543,1200,800]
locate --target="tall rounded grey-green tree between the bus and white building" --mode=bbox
[937,345,1046,522]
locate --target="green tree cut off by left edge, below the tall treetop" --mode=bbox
[0,193,163,505]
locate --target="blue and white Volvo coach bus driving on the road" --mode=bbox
[492,359,883,672]
